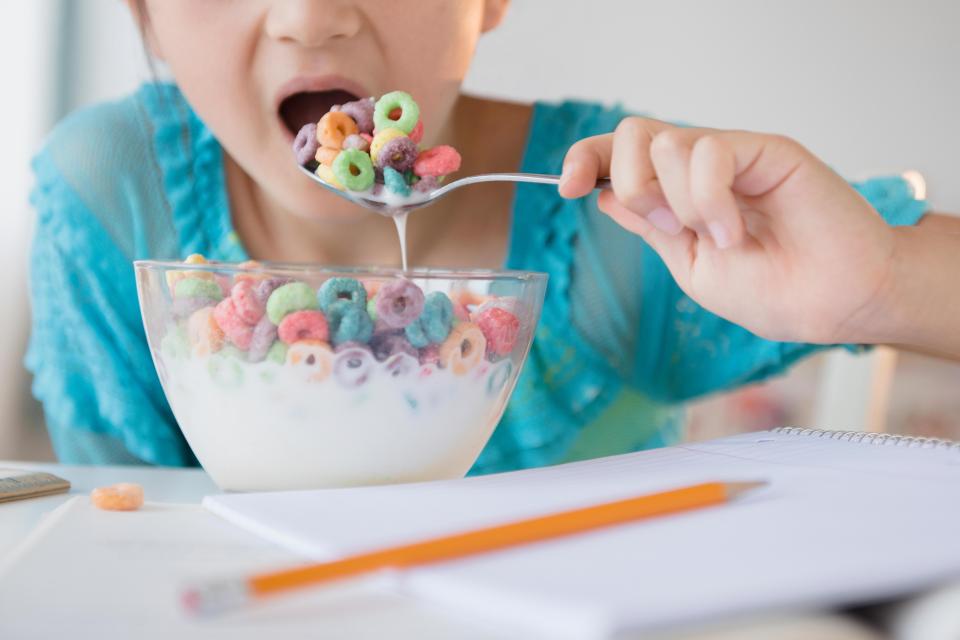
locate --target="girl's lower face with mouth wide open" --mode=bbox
[146,0,509,217]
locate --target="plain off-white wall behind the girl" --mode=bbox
[74,0,960,212]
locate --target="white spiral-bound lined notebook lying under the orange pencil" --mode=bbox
[204,428,960,638]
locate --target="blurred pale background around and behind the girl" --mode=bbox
[0,0,960,459]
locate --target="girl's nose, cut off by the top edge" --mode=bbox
[266,0,362,47]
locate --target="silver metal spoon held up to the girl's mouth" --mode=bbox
[300,166,611,217]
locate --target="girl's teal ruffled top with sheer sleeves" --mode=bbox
[27,85,926,472]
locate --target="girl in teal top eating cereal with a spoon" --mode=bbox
[27,0,960,472]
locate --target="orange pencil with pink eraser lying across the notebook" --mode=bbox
[182,482,766,615]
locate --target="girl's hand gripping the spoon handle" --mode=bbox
[560,118,896,343]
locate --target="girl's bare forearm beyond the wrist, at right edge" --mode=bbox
[857,214,960,360]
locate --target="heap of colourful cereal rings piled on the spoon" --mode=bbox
[293,91,461,198]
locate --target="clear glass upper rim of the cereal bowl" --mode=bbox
[139,260,548,282]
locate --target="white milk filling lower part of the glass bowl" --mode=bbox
[155,353,516,491]
